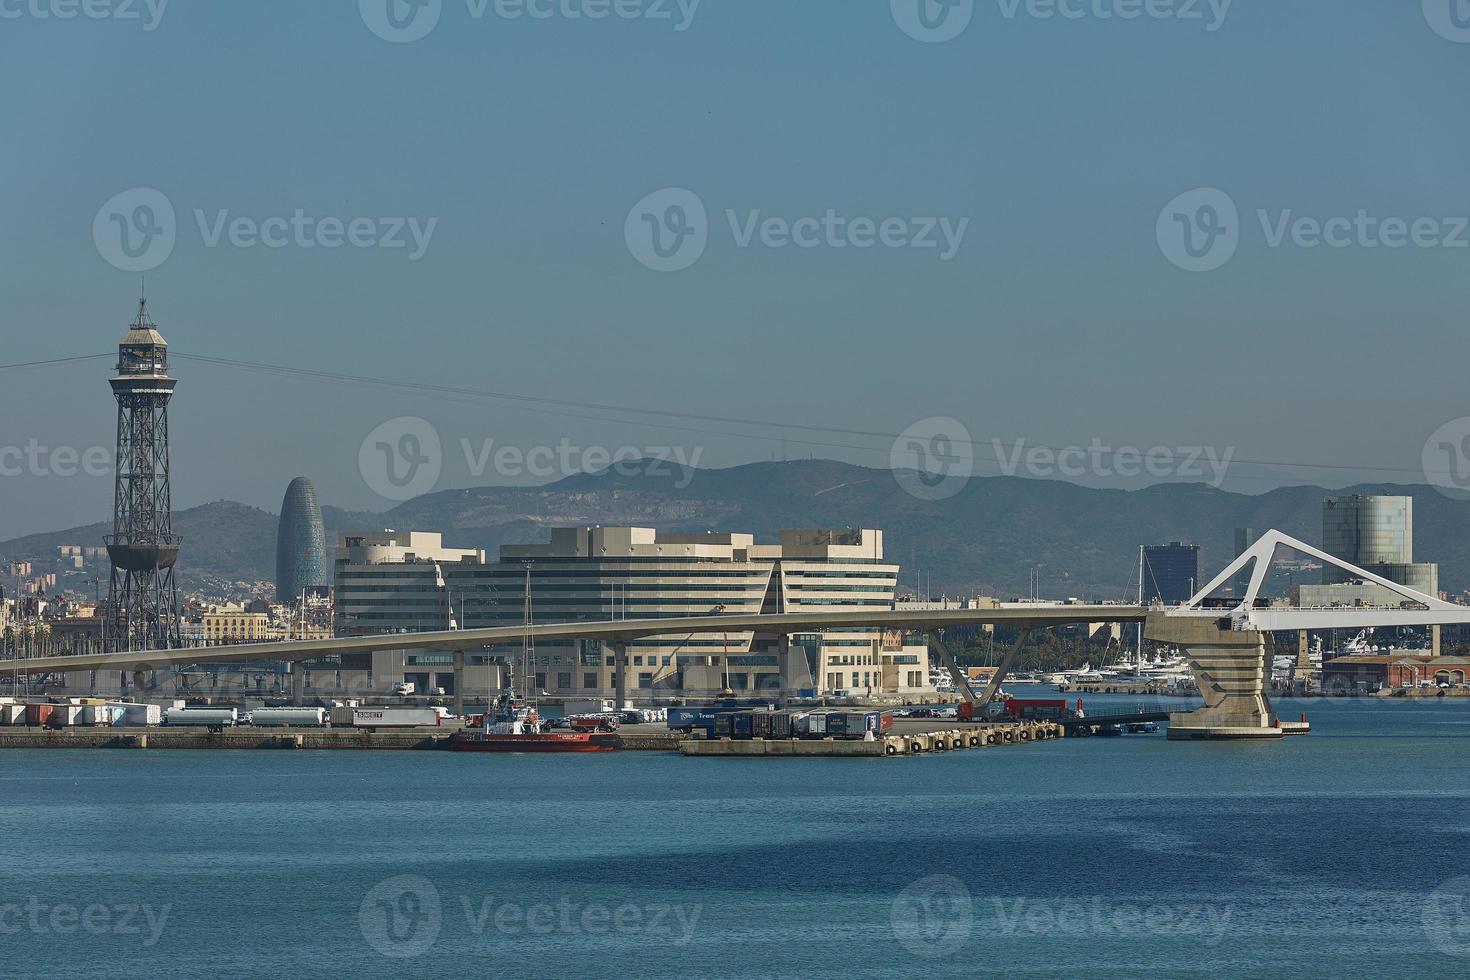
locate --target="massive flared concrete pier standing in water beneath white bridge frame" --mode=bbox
[1144,613,1285,739]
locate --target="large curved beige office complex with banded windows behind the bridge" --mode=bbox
[335,527,932,698]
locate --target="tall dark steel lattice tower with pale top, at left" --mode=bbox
[104,295,182,652]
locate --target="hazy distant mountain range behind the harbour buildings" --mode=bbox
[0,460,1470,599]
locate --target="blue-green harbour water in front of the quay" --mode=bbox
[0,689,1470,980]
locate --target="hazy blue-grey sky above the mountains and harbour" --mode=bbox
[0,0,1470,536]
